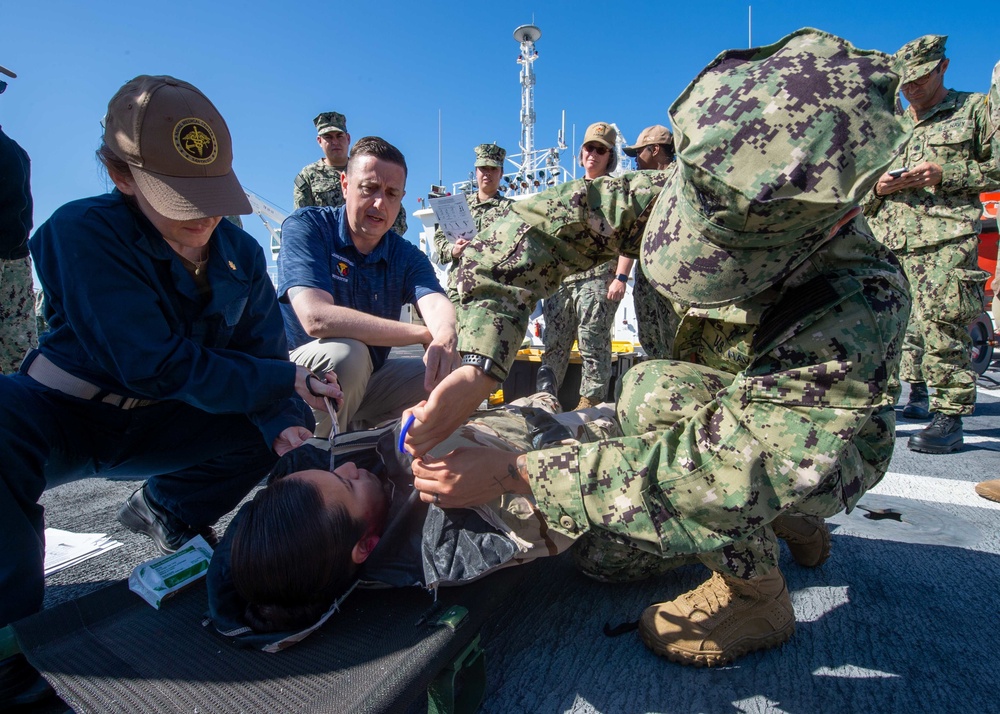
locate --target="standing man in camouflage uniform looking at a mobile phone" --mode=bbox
[865,35,1000,454]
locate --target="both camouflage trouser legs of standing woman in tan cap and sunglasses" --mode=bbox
[542,276,618,402]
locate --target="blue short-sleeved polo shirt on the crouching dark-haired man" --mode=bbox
[278,206,444,369]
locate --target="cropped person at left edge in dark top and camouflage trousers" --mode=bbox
[0,130,38,374]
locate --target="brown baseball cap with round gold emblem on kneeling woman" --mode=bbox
[104,75,251,221]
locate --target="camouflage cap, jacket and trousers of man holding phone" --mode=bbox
[865,35,1000,415]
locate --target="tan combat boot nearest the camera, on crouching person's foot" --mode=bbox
[639,568,795,667]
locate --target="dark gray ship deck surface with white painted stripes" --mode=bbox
[21,356,1000,714]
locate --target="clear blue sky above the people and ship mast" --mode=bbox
[0,0,1000,258]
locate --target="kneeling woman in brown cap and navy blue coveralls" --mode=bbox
[0,76,341,708]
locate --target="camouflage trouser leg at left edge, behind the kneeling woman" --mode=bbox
[0,257,38,374]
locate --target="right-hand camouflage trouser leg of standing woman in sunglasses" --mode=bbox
[570,276,618,402]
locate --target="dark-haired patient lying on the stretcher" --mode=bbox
[208,393,620,649]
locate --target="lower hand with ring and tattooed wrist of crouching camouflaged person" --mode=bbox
[413,447,531,508]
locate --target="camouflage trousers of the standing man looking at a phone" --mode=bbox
[899,237,989,415]
